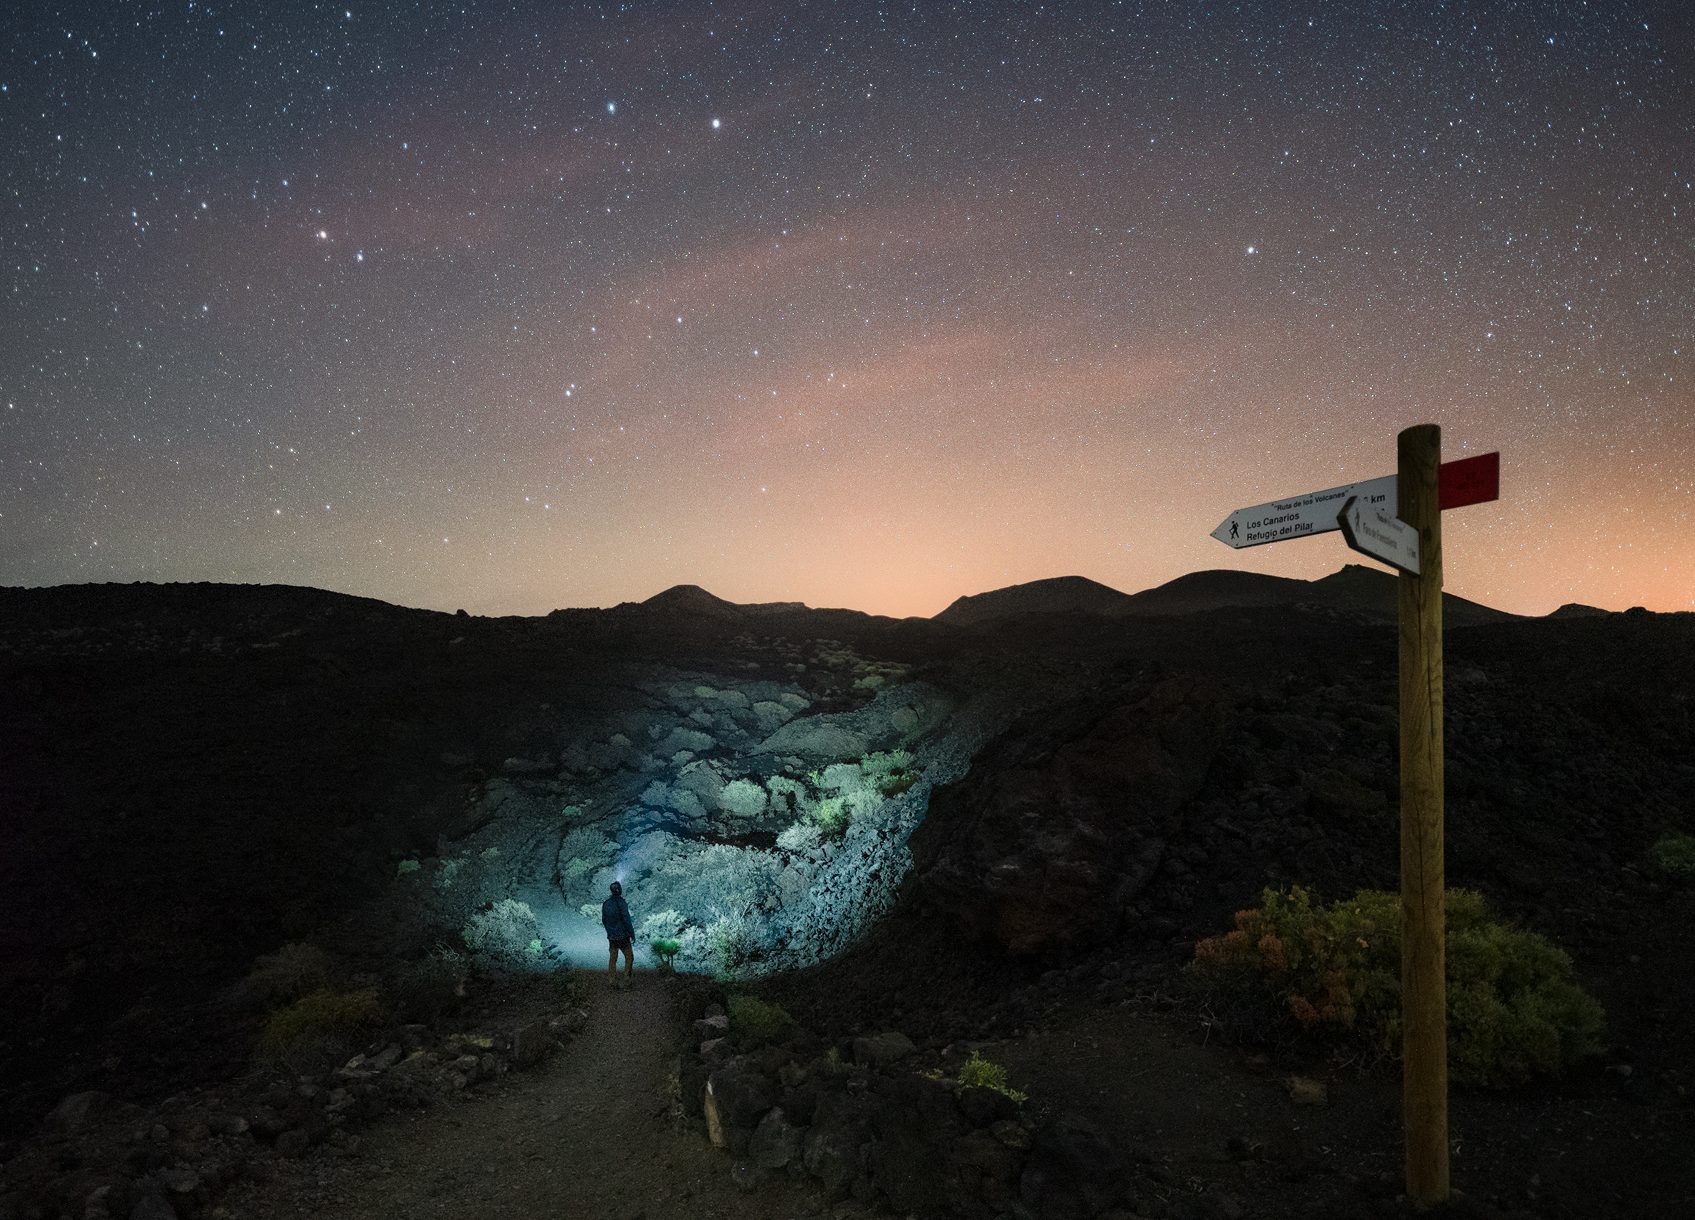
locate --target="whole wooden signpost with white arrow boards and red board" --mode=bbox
[1212,424,1500,1208]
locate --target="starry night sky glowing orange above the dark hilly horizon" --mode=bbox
[0,0,1695,615]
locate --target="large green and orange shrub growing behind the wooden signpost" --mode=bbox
[1190,886,1602,1086]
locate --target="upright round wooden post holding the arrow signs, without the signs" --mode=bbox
[1397,424,1448,1210]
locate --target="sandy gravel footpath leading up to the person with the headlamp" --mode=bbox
[225,974,829,1220]
